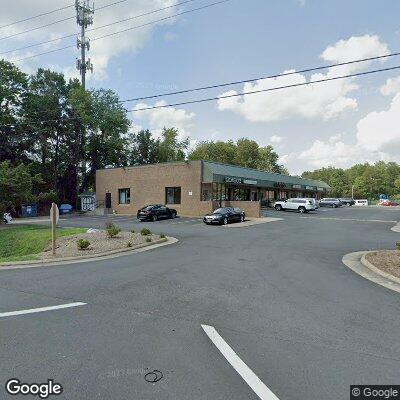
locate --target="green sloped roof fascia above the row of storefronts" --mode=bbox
[203,161,330,189]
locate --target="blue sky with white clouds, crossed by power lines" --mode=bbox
[0,0,400,174]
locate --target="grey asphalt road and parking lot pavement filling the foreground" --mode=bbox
[0,208,400,400]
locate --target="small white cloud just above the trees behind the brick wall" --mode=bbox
[132,100,196,139]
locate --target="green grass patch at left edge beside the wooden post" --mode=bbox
[0,225,87,263]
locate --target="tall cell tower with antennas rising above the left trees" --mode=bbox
[75,0,94,89]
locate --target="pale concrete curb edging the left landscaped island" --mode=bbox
[0,236,178,271]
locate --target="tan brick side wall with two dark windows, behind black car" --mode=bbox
[96,161,212,216]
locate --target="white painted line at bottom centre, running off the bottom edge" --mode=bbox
[201,325,279,400]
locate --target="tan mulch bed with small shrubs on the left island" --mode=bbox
[40,231,160,259]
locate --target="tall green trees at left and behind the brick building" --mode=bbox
[0,60,286,216]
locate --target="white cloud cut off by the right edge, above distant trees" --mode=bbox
[357,93,400,154]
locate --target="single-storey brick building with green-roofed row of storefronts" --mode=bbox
[96,161,330,217]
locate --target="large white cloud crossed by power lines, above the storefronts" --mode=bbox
[218,35,389,122]
